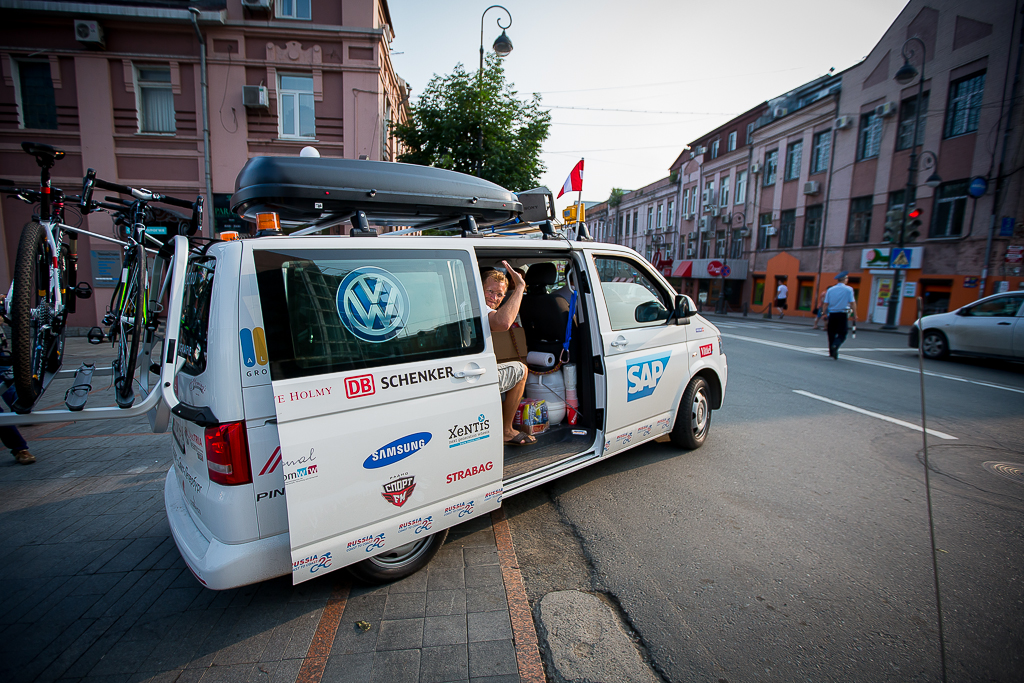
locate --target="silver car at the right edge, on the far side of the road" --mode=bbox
[909,292,1024,360]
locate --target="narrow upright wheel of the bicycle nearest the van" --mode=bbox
[111,245,146,408]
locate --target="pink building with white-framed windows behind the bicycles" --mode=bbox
[0,0,409,328]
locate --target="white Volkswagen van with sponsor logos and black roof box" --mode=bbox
[164,158,727,590]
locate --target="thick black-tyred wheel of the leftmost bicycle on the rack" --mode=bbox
[10,221,66,413]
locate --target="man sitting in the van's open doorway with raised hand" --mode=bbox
[483,261,537,445]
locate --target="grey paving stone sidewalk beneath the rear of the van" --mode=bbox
[0,339,520,683]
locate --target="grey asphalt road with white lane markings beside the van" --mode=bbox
[506,319,1024,683]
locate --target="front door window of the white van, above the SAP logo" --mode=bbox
[594,256,672,330]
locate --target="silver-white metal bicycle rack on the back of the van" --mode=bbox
[0,234,189,433]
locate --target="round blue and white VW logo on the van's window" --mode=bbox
[337,265,409,344]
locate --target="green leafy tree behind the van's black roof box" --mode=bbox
[392,54,551,190]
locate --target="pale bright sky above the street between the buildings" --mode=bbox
[388,0,906,215]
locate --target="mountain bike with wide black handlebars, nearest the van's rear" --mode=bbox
[80,168,203,408]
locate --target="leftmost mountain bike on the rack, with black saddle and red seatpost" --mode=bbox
[0,142,99,414]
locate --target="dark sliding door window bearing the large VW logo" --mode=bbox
[254,250,483,380]
